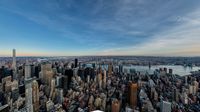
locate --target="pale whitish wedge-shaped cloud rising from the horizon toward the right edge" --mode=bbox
[99,9,200,56]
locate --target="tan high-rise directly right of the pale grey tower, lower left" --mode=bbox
[32,80,39,112]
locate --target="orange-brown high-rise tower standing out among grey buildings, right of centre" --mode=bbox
[129,83,138,109]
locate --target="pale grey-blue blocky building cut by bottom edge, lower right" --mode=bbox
[160,101,171,112]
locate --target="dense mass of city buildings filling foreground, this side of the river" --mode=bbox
[0,50,200,112]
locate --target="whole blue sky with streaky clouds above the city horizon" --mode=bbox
[0,0,200,56]
